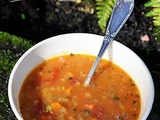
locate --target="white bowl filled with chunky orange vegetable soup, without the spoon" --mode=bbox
[8,33,154,120]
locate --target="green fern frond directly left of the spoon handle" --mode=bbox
[96,0,116,32]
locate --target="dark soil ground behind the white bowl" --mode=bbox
[0,0,160,120]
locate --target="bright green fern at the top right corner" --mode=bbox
[144,0,160,40]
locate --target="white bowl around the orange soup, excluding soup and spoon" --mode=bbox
[8,33,154,120]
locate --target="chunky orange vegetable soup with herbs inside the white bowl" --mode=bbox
[19,54,141,120]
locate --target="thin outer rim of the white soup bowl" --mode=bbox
[8,33,155,120]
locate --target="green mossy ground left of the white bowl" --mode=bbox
[0,32,32,120]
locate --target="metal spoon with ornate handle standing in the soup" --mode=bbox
[84,0,134,85]
